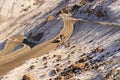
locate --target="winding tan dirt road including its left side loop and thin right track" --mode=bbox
[0,14,120,75]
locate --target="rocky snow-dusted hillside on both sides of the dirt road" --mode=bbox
[0,0,120,80]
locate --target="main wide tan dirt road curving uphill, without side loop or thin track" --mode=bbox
[0,14,76,75]
